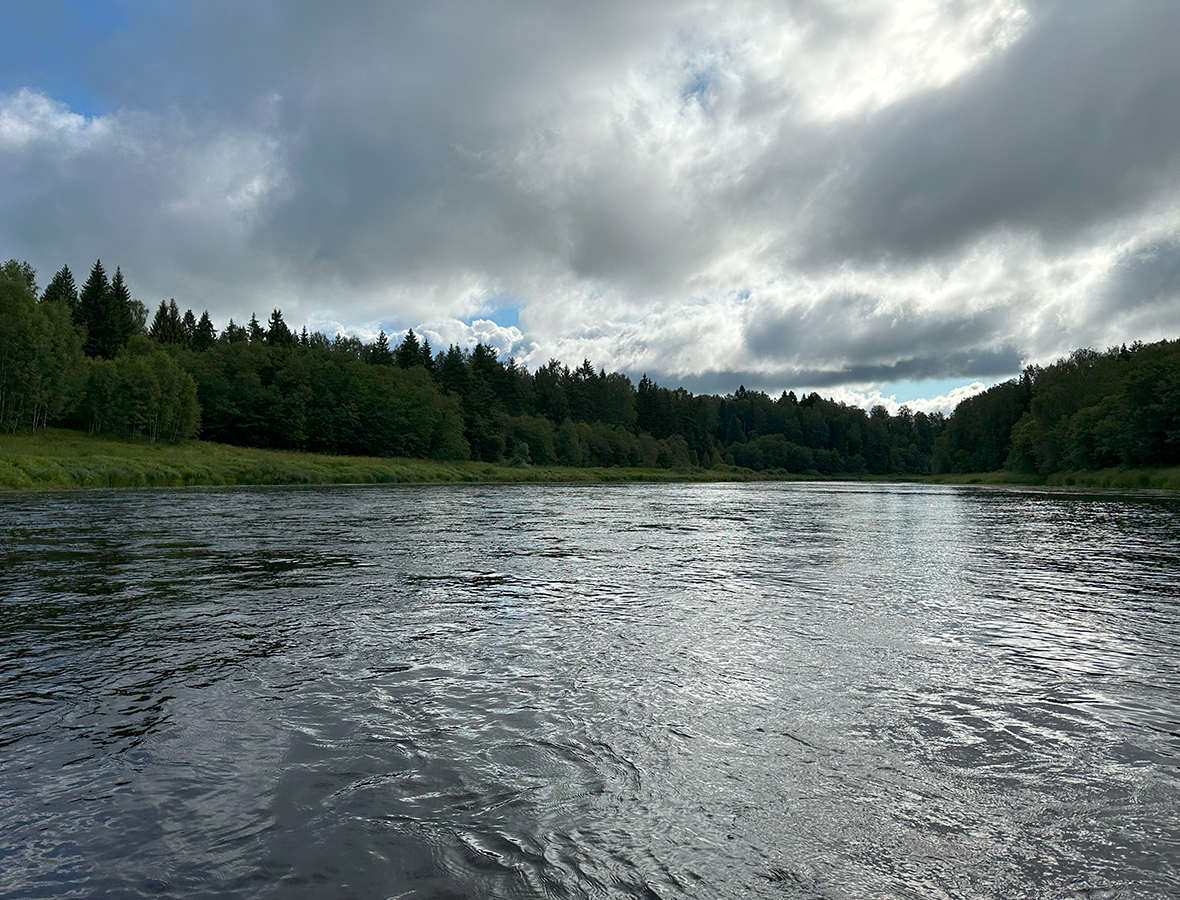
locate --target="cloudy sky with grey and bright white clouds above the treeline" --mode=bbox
[0,0,1180,412]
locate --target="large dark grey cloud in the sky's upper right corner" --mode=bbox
[807,2,1180,264]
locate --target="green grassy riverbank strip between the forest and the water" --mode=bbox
[0,428,1180,491]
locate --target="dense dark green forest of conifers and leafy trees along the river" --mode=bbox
[0,260,1180,475]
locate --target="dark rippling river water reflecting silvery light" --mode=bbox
[0,485,1180,900]
